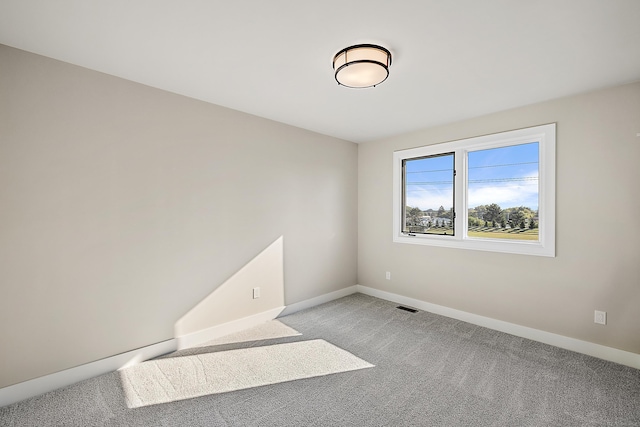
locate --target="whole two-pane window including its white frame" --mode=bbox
[393,124,555,257]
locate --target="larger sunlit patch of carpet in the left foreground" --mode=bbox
[120,339,373,408]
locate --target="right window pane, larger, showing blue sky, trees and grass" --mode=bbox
[467,142,539,241]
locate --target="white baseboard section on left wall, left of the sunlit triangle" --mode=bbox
[0,339,177,407]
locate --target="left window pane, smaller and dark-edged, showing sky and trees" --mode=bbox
[403,153,454,236]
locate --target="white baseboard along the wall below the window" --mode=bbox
[356,285,640,369]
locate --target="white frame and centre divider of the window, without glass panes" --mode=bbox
[393,123,556,257]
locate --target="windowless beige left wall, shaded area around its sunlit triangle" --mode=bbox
[0,46,357,387]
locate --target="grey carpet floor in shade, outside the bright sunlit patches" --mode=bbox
[0,294,640,426]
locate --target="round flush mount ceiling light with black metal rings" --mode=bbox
[333,44,391,88]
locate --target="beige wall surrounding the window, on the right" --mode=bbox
[358,83,640,353]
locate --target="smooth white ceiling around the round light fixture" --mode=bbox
[0,0,640,142]
